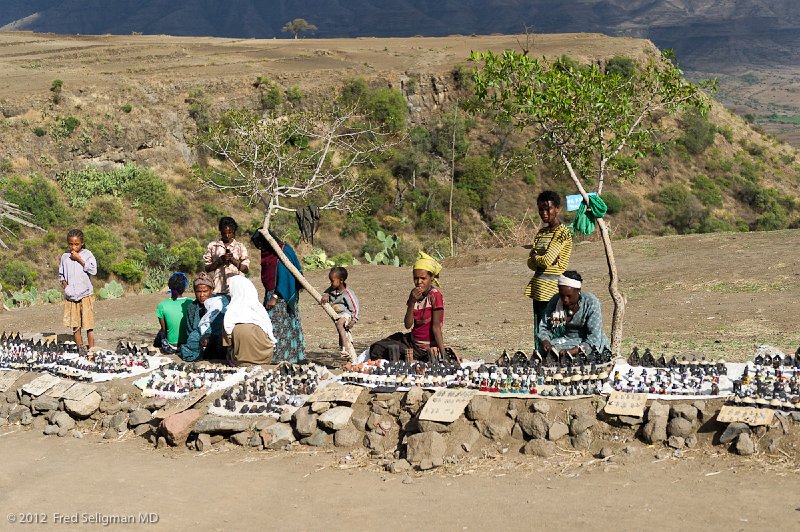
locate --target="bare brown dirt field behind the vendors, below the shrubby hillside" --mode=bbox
[0,230,800,364]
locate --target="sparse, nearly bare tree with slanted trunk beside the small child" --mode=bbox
[198,109,389,359]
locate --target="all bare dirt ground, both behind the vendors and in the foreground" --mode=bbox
[0,231,800,530]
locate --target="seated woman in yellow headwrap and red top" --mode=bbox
[369,251,456,361]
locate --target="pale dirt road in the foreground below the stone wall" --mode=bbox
[0,432,800,530]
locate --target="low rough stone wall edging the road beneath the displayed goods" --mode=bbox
[0,378,800,472]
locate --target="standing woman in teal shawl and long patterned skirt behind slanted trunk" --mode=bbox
[250,231,306,364]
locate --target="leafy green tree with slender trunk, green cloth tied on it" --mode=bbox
[471,46,714,354]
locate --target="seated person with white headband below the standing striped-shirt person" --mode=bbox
[539,270,608,356]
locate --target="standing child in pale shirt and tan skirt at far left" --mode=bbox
[58,229,97,349]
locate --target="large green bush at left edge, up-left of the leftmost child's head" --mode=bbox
[0,174,74,229]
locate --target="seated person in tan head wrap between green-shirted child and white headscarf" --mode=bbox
[180,273,230,362]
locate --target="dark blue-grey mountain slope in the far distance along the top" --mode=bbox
[0,0,800,71]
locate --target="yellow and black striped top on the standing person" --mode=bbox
[525,224,572,301]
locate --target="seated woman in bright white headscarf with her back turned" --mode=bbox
[224,275,275,366]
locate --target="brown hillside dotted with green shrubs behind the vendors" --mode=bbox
[0,32,800,304]
